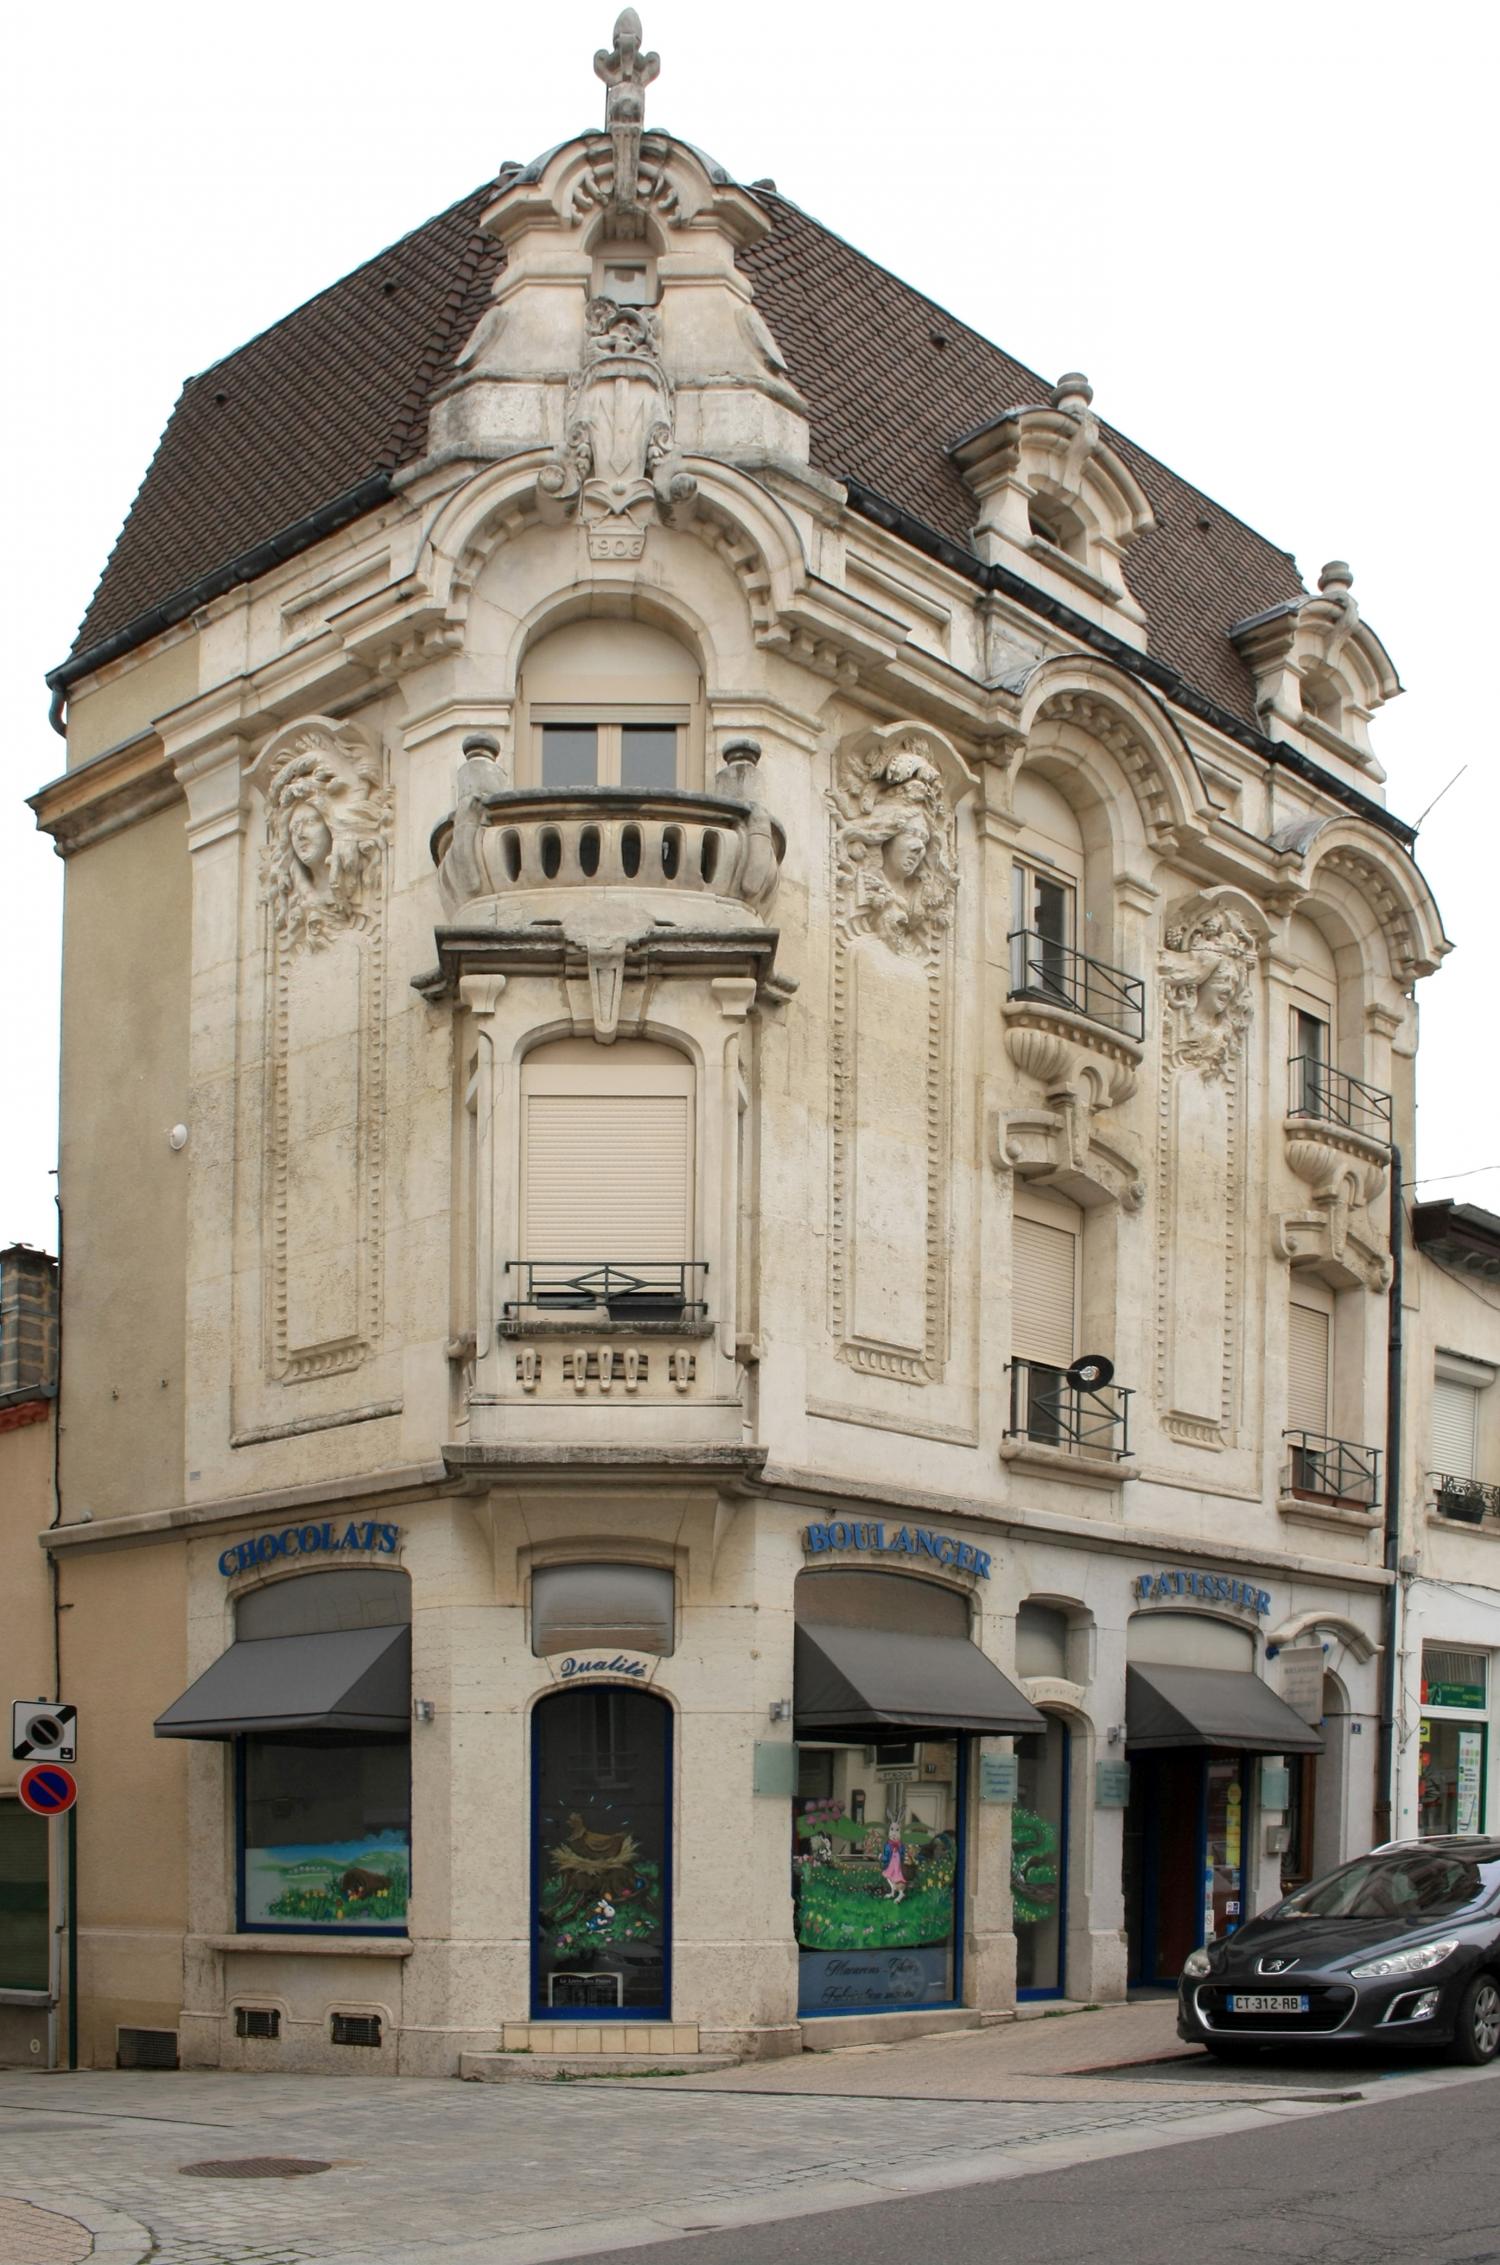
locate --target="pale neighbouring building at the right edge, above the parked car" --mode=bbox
[1396,1200,1500,1832]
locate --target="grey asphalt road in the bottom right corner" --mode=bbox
[555,2075,1500,2265]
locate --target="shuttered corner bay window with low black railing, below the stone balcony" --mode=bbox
[521,1040,702,1320]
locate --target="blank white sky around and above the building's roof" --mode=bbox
[0,0,1500,1248]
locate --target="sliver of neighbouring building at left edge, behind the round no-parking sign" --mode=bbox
[0,1243,57,2068]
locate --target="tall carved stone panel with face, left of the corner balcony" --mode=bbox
[254,716,390,1384]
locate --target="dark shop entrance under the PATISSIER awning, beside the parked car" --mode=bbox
[1124,1746,1246,1989]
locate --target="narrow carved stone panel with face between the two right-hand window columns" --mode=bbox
[1158,901,1260,1447]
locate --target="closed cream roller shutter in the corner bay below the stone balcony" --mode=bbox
[523,1092,691,1266]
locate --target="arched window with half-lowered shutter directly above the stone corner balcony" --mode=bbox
[519,621,702,795]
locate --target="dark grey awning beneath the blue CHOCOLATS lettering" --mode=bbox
[156,1629,412,1737]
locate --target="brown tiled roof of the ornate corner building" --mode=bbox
[61,183,1303,723]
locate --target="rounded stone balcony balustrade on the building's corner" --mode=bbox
[433,786,786,922]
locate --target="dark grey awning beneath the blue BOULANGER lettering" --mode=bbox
[793,1619,1045,1742]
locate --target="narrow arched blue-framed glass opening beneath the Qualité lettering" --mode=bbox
[532,1685,671,2018]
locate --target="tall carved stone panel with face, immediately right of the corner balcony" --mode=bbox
[829,725,972,1384]
